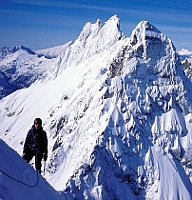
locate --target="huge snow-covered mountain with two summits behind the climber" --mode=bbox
[0,16,192,200]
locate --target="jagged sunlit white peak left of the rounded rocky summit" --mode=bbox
[59,15,123,73]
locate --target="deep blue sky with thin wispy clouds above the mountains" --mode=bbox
[0,0,192,51]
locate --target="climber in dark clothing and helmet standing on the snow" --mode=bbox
[23,118,48,173]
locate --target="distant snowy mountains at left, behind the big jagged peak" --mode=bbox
[0,43,70,99]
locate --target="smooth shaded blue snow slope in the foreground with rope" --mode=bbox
[0,139,63,200]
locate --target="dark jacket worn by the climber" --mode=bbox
[23,125,47,153]
